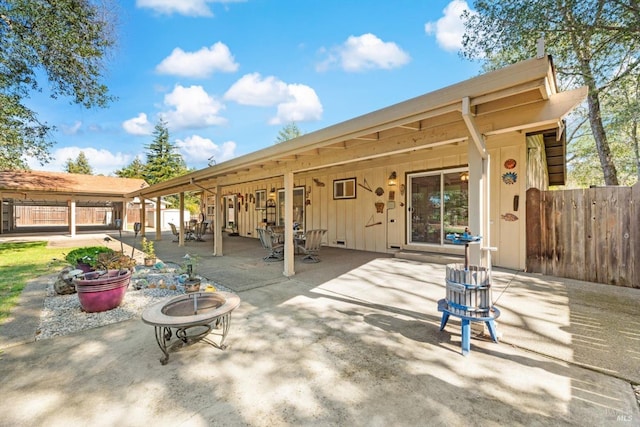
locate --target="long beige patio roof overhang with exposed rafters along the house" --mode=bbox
[126,56,587,198]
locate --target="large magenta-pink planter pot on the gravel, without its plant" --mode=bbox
[73,270,131,313]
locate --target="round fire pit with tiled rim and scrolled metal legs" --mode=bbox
[142,291,240,365]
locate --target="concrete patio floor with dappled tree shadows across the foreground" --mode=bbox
[0,233,640,426]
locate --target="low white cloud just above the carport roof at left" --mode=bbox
[27,147,135,175]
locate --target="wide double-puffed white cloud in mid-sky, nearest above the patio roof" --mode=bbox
[224,73,323,124]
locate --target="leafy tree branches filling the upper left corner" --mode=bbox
[0,0,117,169]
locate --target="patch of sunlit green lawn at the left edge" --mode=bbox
[0,241,79,325]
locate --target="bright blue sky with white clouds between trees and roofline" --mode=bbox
[29,0,479,175]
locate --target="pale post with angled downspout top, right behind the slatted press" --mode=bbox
[462,97,493,268]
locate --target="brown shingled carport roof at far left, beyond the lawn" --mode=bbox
[0,170,149,201]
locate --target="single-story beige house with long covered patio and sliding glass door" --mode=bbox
[132,56,587,276]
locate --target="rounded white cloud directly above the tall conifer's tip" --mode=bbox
[160,85,227,129]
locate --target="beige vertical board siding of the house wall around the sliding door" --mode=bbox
[214,132,527,269]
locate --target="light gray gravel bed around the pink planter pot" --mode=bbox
[36,272,232,341]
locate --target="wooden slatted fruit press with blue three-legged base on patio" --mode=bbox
[438,232,500,356]
